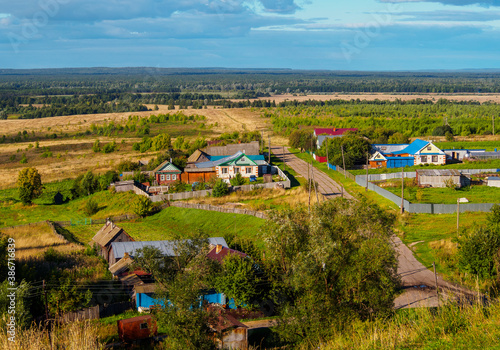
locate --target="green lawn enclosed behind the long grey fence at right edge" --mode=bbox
[384,181,500,204]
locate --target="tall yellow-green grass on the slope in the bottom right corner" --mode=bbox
[321,301,500,350]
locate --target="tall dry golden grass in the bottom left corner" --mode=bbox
[0,321,103,350]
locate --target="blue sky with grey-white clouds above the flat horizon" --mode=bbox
[0,0,500,70]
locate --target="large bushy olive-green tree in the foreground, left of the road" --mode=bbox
[264,199,399,344]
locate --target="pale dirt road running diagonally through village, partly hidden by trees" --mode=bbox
[272,147,474,309]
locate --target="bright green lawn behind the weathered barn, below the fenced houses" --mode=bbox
[66,207,266,247]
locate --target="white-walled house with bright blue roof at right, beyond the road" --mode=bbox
[370,139,446,168]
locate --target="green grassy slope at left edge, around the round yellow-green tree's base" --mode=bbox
[0,187,136,227]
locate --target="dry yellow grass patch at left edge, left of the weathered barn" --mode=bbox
[1,223,83,260]
